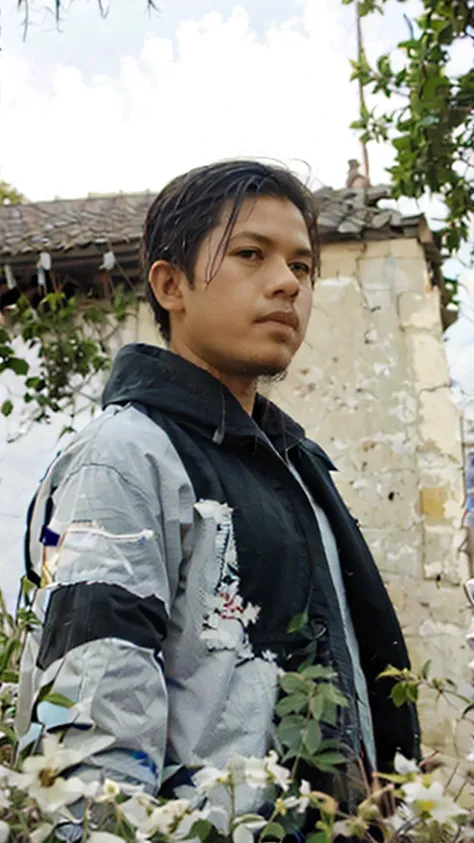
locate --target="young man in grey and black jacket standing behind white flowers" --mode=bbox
[19,161,419,820]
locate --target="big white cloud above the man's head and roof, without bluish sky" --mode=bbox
[2,0,372,200]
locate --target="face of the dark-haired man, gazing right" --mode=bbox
[171,196,314,377]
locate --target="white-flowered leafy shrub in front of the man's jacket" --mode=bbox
[0,593,474,843]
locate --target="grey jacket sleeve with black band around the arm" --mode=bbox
[18,407,194,791]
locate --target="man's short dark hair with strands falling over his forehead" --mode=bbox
[142,160,319,342]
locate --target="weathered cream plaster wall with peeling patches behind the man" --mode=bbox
[0,240,470,754]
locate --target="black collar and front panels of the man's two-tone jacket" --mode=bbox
[103,344,419,770]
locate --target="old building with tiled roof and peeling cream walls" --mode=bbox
[0,187,470,776]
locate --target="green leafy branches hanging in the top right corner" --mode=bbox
[343,0,474,254]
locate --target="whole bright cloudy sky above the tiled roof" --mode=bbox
[0,0,426,200]
